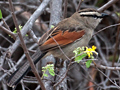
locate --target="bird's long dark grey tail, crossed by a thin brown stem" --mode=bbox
[7,49,46,87]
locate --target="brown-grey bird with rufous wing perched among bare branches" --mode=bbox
[7,8,108,87]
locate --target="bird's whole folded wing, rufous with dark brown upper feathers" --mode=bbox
[39,26,85,51]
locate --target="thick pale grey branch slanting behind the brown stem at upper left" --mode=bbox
[8,0,50,57]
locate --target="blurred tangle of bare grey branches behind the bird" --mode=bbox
[0,0,120,90]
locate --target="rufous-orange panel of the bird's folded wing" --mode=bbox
[40,30,85,51]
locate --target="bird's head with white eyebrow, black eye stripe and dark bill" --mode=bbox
[72,8,108,29]
